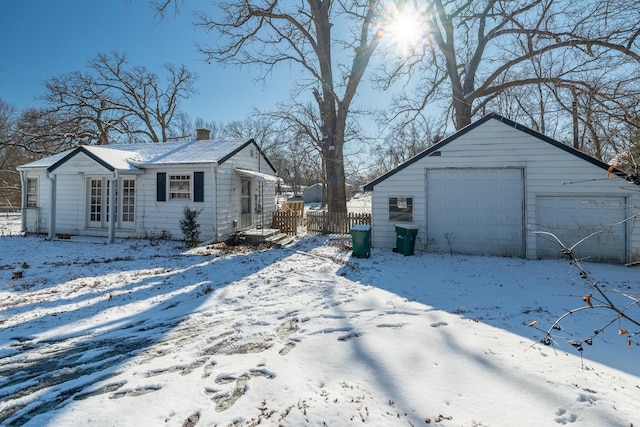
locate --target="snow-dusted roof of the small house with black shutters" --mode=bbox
[18,139,275,172]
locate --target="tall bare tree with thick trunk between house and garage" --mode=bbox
[155,0,388,212]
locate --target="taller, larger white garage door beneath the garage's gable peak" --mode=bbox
[427,169,525,257]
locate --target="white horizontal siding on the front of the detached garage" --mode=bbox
[372,119,640,261]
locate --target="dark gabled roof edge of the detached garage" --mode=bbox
[364,113,633,191]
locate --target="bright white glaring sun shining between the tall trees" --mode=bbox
[383,3,425,55]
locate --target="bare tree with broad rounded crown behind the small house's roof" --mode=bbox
[42,52,197,144]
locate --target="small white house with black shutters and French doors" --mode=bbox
[18,133,279,241]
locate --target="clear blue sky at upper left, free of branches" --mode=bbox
[0,0,291,122]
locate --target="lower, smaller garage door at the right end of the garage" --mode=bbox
[536,196,626,263]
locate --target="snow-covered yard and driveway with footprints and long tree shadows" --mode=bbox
[0,216,640,426]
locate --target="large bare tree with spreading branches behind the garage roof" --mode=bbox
[382,0,640,130]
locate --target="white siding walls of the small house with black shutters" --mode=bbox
[24,144,275,241]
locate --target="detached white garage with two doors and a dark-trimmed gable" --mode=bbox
[365,114,640,263]
